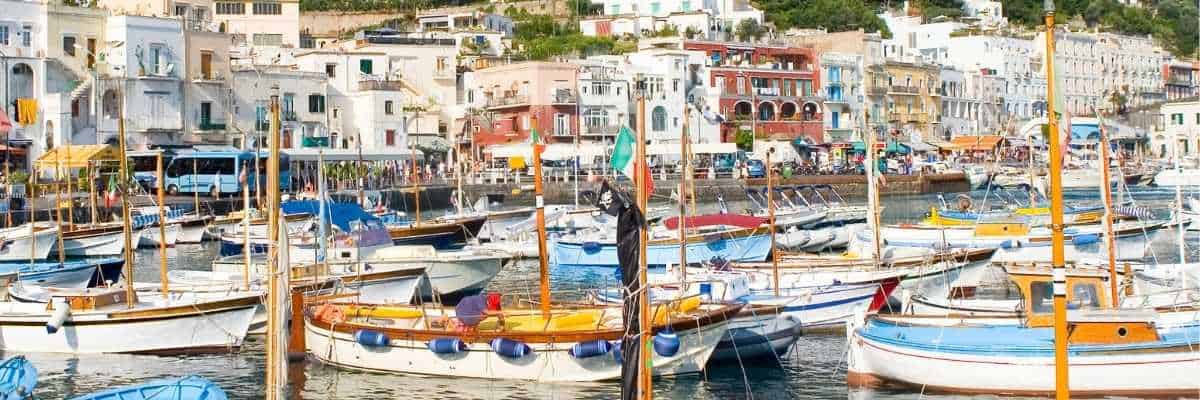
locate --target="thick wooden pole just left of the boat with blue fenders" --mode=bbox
[266,85,286,400]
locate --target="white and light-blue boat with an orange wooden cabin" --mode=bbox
[846,263,1200,396]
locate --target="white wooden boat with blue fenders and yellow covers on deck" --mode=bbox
[305,299,742,382]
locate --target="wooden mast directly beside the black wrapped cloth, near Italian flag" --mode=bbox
[634,92,654,400]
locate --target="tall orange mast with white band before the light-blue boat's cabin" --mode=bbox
[1043,0,1070,400]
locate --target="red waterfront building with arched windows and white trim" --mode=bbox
[684,41,824,144]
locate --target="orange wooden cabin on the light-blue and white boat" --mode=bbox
[1004,265,1159,345]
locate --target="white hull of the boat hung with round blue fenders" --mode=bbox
[305,314,728,382]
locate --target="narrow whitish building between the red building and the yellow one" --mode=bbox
[821,52,865,143]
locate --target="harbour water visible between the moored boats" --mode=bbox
[14,187,1200,399]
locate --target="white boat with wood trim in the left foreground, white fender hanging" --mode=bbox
[0,288,259,353]
